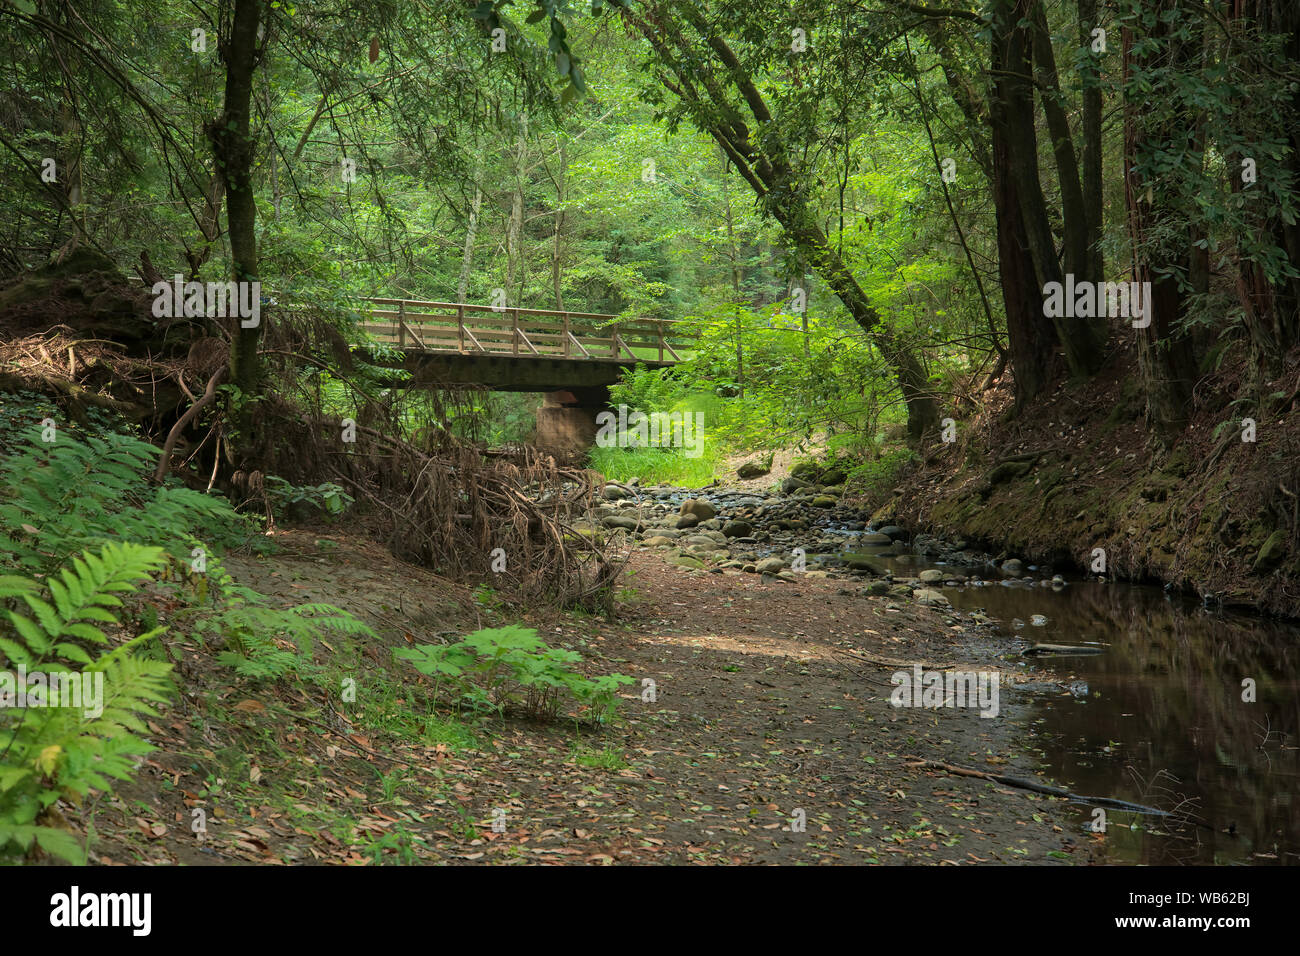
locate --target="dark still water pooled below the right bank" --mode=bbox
[837,549,1300,865]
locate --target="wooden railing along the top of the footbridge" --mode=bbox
[363,299,681,363]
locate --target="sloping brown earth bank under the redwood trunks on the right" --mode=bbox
[871,343,1300,617]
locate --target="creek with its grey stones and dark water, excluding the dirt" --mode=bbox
[585,479,1300,864]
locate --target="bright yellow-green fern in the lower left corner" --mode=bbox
[0,542,172,862]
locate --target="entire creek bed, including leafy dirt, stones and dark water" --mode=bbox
[76,485,1297,865]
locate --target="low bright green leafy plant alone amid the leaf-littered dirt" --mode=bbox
[393,624,633,723]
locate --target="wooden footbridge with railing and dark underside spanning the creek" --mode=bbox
[361,299,681,392]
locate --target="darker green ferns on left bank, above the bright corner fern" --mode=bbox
[0,427,252,571]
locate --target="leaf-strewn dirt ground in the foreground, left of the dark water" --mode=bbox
[74,531,1086,864]
